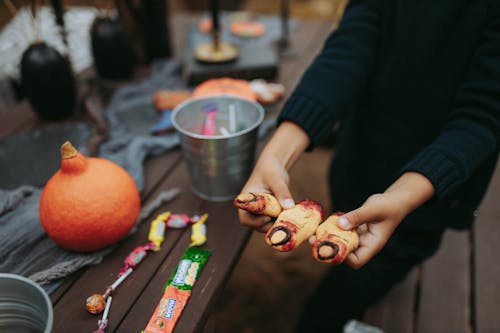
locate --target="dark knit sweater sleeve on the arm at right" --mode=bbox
[402,4,500,200]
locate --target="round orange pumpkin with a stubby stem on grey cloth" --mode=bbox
[40,142,141,252]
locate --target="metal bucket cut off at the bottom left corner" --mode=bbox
[0,273,53,333]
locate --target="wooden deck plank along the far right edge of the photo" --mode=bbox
[473,163,500,333]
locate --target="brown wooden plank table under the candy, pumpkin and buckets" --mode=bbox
[0,16,331,333]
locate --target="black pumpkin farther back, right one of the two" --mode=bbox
[90,16,136,80]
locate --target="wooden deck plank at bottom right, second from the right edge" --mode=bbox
[417,230,471,333]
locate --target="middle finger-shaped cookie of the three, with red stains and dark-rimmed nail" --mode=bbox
[266,200,323,251]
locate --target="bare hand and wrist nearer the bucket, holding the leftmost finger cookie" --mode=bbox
[234,121,309,232]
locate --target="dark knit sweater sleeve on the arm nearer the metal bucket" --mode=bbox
[278,0,380,150]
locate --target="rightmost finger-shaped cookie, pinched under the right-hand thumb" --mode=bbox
[312,213,359,264]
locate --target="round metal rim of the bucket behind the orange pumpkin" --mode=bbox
[170,94,265,140]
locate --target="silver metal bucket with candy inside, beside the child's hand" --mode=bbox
[172,95,264,201]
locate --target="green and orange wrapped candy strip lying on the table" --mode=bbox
[142,247,212,333]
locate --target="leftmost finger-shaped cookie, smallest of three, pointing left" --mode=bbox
[234,192,281,217]
